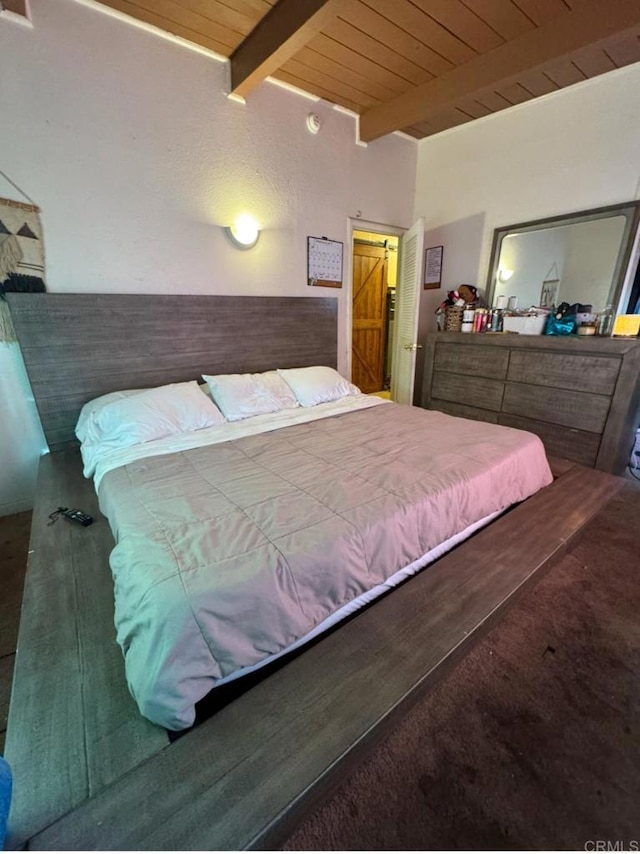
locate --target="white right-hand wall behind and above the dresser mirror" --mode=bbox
[415,63,640,330]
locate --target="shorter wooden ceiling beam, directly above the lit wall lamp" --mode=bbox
[231,0,340,97]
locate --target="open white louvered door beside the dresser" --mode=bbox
[391,217,424,404]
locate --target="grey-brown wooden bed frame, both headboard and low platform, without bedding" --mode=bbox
[6,294,622,850]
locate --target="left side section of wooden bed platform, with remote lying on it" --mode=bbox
[5,449,169,846]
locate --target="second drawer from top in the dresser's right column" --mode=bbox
[502,383,611,433]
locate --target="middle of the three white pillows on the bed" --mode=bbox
[202,371,298,421]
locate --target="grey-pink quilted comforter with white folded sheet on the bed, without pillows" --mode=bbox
[82,388,552,730]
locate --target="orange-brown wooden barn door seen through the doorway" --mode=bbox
[351,243,387,394]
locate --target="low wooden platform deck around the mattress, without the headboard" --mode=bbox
[7,452,622,850]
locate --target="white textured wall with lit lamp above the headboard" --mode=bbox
[0,0,417,513]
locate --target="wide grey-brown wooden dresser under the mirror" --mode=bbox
[421,332,640,474]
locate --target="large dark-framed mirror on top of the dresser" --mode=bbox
[487,202,640,312]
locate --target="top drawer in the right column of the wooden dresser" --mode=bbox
[507,350,621,395]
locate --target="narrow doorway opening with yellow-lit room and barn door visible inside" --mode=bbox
[351,230,399,398]
